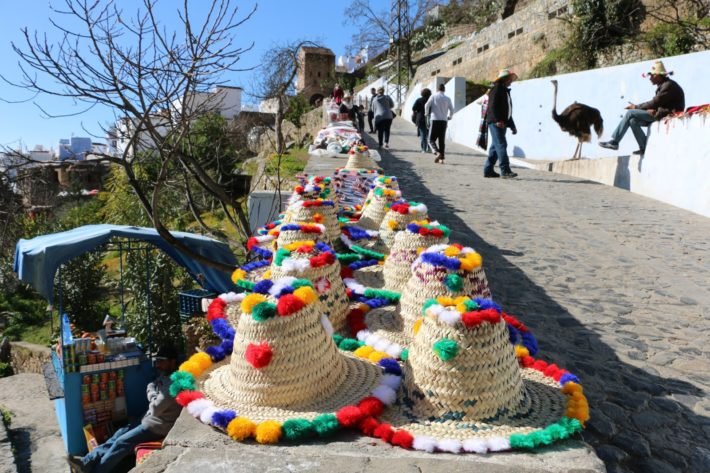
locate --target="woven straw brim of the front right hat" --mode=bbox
[381,368,567,440]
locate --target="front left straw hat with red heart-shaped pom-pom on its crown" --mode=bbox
[170,278,401,443]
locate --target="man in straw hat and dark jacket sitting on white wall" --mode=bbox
[599,61,685,154]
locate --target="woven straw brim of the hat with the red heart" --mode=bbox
[198,351,382,422]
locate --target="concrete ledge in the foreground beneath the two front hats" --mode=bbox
[132,410,606,473]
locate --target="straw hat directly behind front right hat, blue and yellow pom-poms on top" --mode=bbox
[365,243,491,346]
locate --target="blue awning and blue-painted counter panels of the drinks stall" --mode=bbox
[14,225,237,455]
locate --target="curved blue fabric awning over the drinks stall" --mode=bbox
[14,225,237,302]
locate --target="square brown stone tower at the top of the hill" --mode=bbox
[296,47,335,104]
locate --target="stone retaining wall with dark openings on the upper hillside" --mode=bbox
[414,0,570,83]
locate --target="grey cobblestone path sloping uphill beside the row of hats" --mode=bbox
[367,119,710,473]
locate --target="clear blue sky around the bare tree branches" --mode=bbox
[0,0,356,149]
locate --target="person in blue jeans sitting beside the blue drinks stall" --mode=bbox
[67,347,182,473]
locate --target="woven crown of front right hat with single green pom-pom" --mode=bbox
[401,296,530,422]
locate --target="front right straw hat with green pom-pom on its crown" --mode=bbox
[372,297,589,453]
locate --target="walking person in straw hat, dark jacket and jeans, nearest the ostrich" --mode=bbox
[483,69,518,178]
